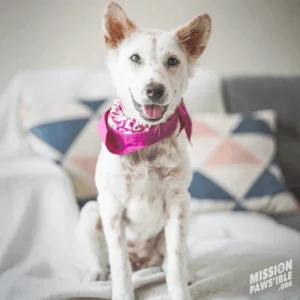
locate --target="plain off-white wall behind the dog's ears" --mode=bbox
[0,0,300,92]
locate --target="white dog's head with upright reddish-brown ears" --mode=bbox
[104,2,211,124]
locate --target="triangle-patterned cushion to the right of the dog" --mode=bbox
[189,111,297,214]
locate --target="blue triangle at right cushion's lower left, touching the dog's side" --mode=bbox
[189,172,233,200]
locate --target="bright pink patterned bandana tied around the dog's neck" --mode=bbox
[97,99,192,155]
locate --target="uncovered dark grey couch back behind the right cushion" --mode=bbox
[222,75,300,201]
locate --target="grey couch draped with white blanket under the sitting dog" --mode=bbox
[0,70,300,300]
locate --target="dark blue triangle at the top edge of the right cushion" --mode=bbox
[232,117,274,135]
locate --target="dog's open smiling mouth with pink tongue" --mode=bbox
[130,92,169,122]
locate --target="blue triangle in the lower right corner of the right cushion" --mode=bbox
[245,169,286,199]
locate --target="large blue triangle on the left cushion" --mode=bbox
[30,118,89,154]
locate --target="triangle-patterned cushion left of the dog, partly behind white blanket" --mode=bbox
[22,99,108,205]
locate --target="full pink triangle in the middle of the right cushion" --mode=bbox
[204,139,260,166]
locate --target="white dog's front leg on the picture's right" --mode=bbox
[165,192,192,300]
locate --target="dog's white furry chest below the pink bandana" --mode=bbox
[122,139,184,236]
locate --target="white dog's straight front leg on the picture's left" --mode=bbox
[100,193,134,300]
